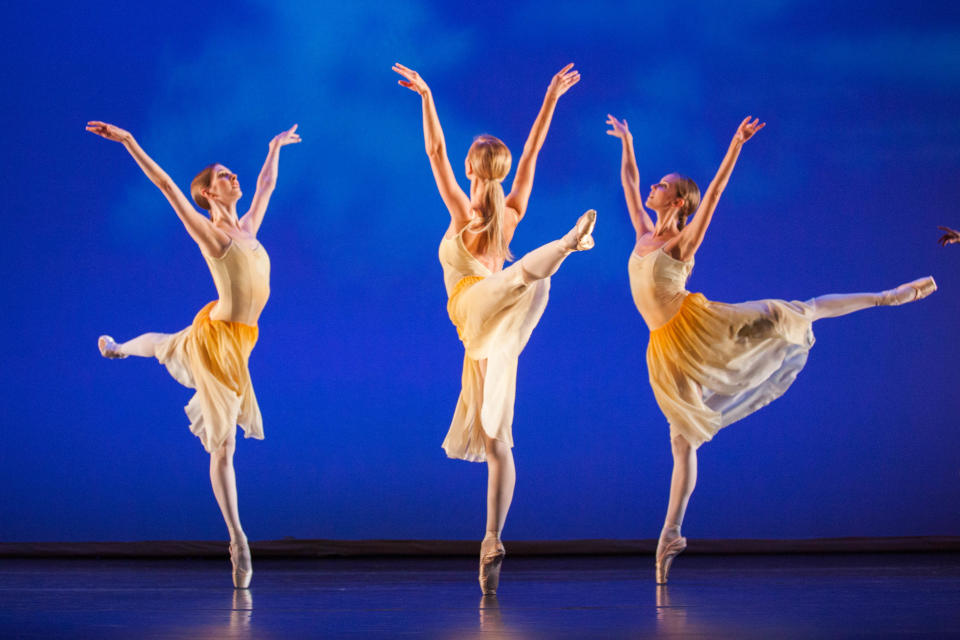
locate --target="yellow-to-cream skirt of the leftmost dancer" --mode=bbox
[157,301,263,452]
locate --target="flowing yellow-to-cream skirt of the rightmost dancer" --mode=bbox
[647,293,814,447]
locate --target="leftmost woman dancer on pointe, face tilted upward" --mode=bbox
[87,121,300,588]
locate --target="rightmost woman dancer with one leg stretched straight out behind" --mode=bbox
[607,116,937,584]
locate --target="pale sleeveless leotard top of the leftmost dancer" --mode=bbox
[203,240,270,326]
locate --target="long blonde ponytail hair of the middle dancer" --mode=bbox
[467,134,513,260]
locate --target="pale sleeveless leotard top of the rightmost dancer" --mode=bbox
[627,249,693,331]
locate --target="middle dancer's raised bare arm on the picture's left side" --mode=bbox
[393,62,470,231]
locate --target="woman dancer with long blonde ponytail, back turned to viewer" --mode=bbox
[393,63,596,595]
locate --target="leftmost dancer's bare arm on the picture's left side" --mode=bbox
[87,120,230,256]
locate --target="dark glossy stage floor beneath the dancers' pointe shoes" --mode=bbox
[0,553,960,640]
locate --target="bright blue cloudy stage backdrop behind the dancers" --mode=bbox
[0,0,960,541]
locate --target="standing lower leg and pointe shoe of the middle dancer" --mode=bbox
[480,435,517,595]
